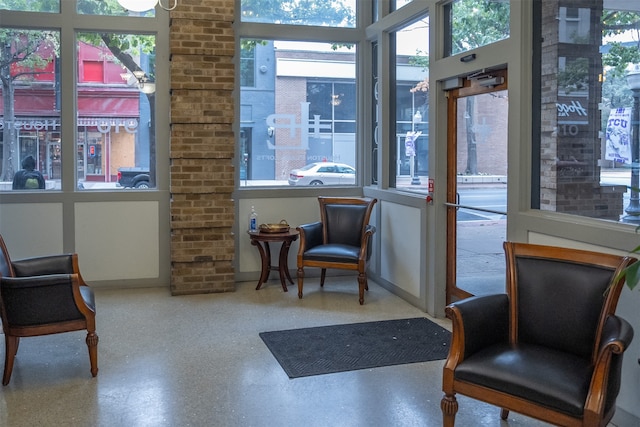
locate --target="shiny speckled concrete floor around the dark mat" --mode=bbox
[0,277,564,427]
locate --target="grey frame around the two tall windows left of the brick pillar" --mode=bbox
[2,0,170,196]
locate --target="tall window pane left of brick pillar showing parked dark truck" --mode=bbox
[77,33,155,189]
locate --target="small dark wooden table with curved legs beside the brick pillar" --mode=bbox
[248,230,299,292]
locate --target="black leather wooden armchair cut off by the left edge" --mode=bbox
[0,236,98,385]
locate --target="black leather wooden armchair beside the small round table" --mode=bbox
[297,197,378,305]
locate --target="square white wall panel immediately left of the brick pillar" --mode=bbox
[75,201,159,282]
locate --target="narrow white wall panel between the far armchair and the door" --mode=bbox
[378,202,422,297]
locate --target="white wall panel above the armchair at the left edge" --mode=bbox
[0,203,63,259]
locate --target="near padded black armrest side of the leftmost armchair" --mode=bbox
[0,274,91,327]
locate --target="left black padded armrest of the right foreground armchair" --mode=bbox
[445,294,509,362]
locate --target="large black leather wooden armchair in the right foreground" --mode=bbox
[441,242,635,427]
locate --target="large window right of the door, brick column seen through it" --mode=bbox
[532,3,640,224]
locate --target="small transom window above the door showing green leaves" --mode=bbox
[445,0,510,55]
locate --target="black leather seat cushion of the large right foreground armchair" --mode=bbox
[454,343,593,417]
